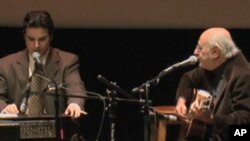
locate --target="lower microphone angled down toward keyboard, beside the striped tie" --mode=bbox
[20,82,30,114]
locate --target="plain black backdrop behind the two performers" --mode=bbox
[0,27,250,141]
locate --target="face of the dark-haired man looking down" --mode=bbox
[24,27,51,56]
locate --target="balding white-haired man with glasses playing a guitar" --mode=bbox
[176,27,250,141]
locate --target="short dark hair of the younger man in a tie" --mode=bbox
[23,10,54,36]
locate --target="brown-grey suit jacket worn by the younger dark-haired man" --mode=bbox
[0,48,85,114]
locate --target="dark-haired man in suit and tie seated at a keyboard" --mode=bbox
[0,11,86,118]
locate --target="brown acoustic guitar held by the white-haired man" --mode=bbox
[180,90,214,140]
